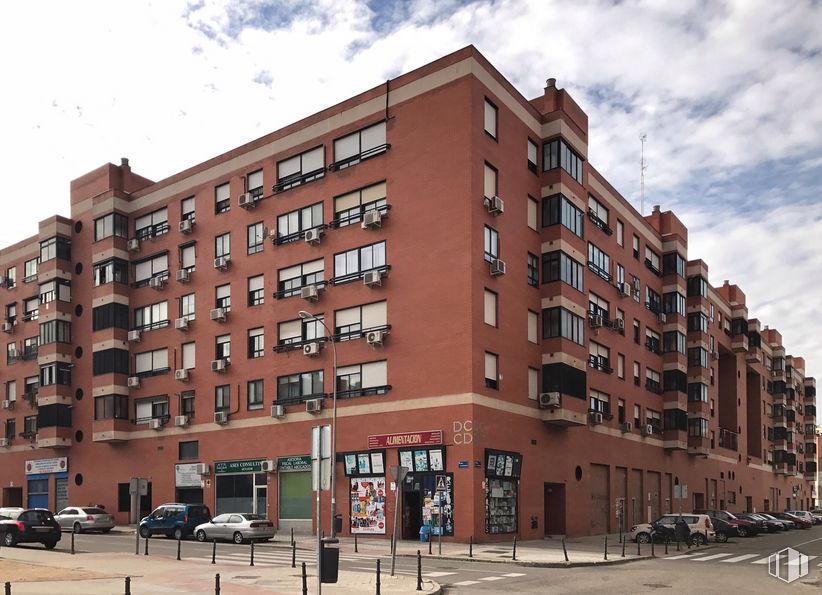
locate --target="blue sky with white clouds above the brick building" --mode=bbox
[0,0,822,376]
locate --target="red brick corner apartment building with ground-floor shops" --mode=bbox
[0,47,817,541]
